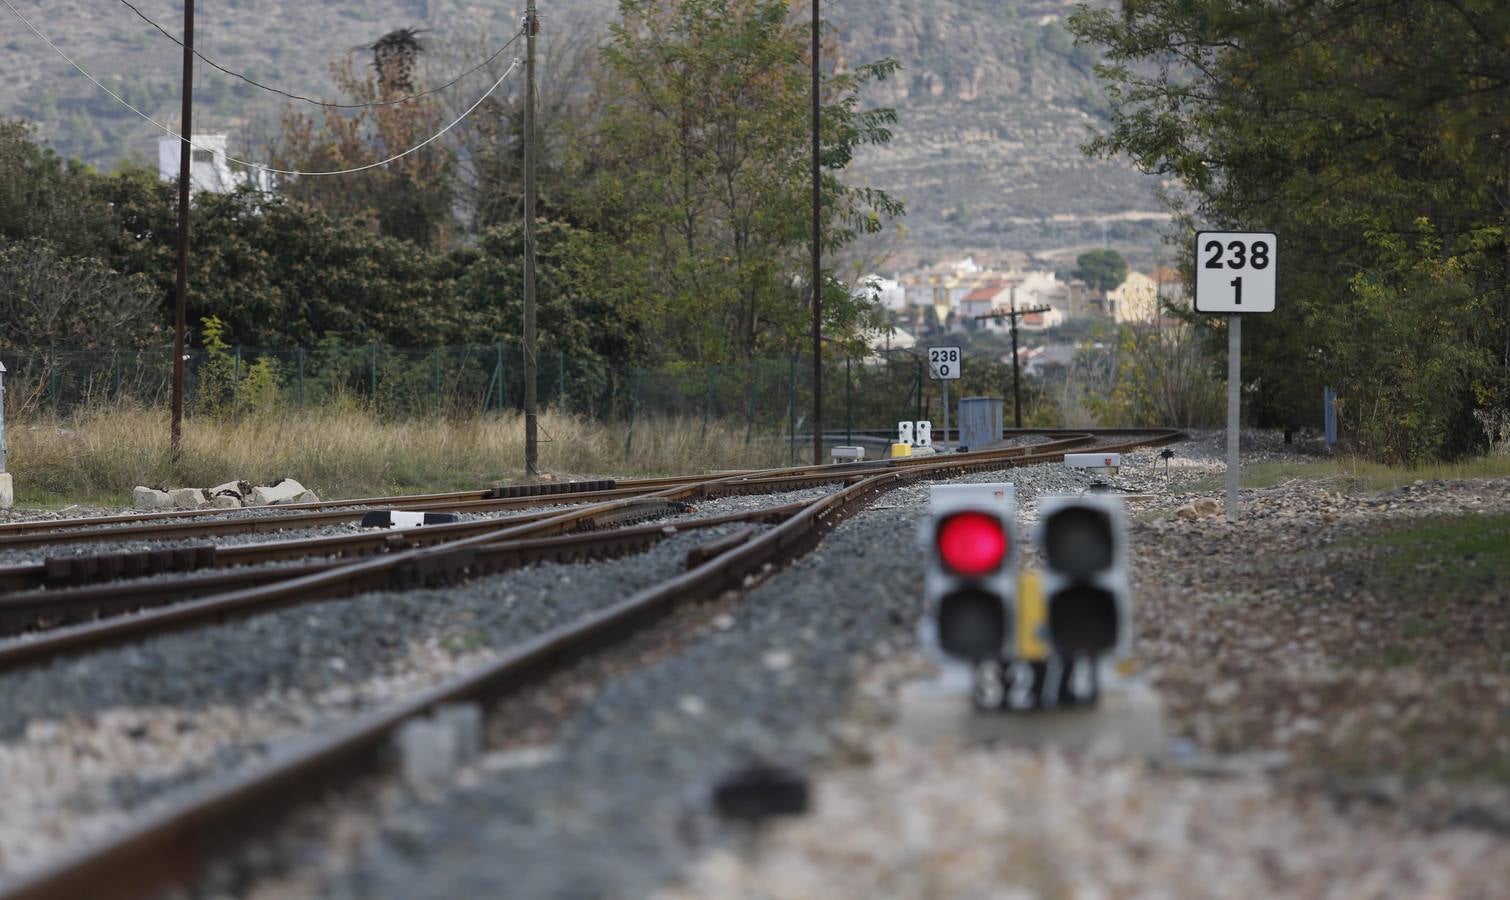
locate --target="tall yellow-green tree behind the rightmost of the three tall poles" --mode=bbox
[575,0,901,362]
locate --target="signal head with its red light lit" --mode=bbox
[923,483,1018,664]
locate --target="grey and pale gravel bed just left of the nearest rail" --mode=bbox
[0,495,796,873]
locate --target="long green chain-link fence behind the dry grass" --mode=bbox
[0,344,1044,439]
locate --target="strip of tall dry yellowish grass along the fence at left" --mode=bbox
[8,408,787,506]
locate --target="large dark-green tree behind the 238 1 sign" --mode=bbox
[1072,0,1510,461]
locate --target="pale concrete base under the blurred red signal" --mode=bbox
[897,672,1169,760]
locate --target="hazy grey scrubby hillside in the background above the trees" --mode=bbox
[0,0,1160,255]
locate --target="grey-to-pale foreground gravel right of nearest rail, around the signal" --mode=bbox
[209,436,1510,898]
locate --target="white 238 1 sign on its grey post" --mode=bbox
[1196,231,1279,522]
